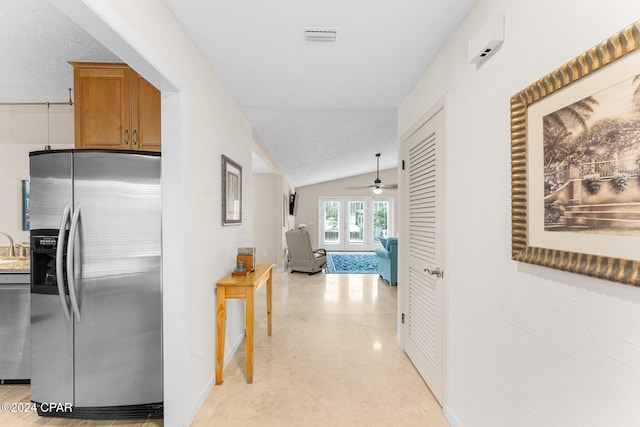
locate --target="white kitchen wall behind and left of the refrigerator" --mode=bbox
[0,104,74,245]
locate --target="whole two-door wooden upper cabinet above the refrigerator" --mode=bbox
[70,62,161,151]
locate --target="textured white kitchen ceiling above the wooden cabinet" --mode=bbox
[0,0,120,101]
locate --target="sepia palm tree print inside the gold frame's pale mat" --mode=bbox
[542,74,640,235]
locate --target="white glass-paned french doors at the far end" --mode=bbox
[318,197,393,251]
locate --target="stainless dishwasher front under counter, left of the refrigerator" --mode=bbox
[0,273,31,384]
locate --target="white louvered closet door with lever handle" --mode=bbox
[403,106,445,405]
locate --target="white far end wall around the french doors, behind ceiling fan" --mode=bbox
[292,168,398,248]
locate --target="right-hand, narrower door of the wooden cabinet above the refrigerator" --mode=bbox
[131,71,161,151]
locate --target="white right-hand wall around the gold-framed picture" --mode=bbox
[398,0,640,427]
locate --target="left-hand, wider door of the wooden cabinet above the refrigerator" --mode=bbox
[74,68,132,149]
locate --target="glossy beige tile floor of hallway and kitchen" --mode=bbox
[0,273,449,427]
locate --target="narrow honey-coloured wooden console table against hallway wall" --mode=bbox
[216,264,273,385]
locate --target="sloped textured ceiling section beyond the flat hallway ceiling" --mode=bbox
[245,108,397,186]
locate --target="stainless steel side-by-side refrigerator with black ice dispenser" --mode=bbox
[29,150,163,419]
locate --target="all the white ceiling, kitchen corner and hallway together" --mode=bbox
[0,0,473,187]
